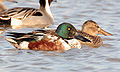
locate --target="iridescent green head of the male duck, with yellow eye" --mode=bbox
[56,23,77,38]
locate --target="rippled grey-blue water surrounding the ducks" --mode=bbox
[0,0,120,72]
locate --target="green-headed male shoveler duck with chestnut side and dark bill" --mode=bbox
[5,23,90,51]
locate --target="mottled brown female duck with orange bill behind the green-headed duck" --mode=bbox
[78,20,112,48]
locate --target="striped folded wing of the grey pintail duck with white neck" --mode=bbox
[0,7,42,20]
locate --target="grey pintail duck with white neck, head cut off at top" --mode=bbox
[0,0,55,29]
